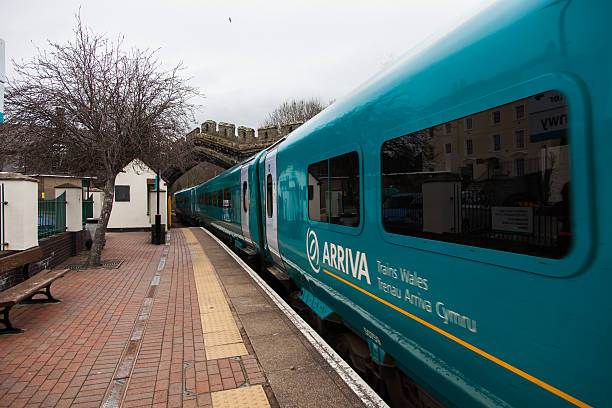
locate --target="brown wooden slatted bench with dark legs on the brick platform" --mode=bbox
[0,247,68,334]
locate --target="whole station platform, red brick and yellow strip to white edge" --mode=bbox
[0,228,384,408]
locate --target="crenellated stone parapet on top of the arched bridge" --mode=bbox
[187,120,304,144]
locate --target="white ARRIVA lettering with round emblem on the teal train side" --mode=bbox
[306,228,371,284]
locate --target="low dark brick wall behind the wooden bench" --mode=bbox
[0,231,85,291]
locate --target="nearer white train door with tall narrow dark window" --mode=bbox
[264,149,283,266]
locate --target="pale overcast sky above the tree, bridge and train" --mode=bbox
[0,0,490,128]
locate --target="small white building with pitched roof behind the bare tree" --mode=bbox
[108,160,168,229]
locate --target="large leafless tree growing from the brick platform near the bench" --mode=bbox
[6,16,197,265]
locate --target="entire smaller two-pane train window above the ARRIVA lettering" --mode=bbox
[308,152,360,227]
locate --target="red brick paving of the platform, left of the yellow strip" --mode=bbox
[0,231,266,407]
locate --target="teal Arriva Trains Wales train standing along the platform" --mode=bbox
[175,0,612,407]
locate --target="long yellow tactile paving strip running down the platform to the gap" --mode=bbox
[181,228,248,360]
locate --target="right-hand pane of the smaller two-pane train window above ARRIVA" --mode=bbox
[329,152,359,227]
